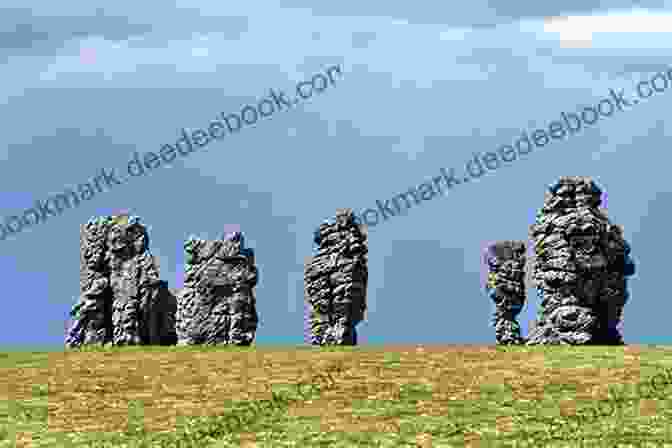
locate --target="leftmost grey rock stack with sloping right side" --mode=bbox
[65,215,177,348]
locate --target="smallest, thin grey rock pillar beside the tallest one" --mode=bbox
[485,241,526,345]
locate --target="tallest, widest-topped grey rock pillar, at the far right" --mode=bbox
[527,177,628,345]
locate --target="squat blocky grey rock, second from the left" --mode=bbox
[176,232,259,346]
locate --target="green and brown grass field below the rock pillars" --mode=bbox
[0,345,672,448]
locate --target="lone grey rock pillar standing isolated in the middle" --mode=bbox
[304,209,368,345]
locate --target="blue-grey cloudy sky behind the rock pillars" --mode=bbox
[0,0,672,349]
